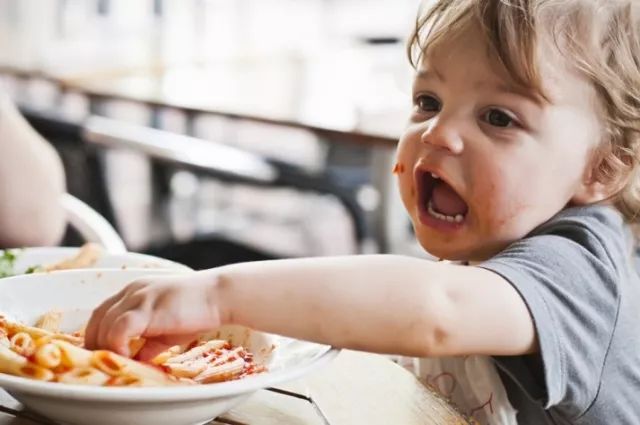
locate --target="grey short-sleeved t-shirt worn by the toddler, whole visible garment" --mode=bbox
[480,206,640,425]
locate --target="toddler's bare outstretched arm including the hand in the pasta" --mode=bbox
[87,255,536,356]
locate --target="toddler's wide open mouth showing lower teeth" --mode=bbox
[417,171,469,225]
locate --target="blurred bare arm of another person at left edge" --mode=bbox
[0,95,65,248]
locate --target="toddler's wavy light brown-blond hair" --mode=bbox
[407,0,640,229]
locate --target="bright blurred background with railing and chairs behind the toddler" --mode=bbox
[0,0,430,268]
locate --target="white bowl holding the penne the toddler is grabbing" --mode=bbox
[0,269,337,425]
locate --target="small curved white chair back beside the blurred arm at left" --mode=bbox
[61,193,127,254]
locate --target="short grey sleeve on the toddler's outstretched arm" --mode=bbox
[480,208,629,416]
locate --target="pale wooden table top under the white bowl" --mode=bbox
[0,351,468,425]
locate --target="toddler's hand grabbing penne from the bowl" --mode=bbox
[86,273,221,360]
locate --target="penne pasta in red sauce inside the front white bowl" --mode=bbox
[0,314,265,387]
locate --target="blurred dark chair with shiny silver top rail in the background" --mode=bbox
[22,108,367,269]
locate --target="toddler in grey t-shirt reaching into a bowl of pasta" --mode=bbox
[87,0,640,425]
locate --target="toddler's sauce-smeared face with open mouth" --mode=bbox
[396,25,602,261]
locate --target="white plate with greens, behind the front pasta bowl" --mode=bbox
[0,247,191,274]
